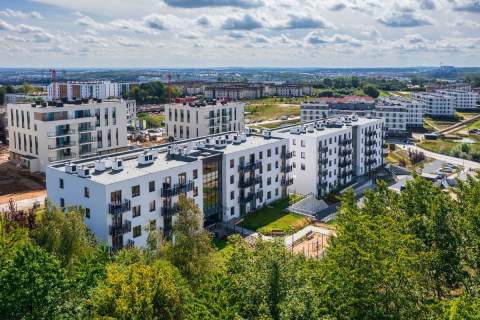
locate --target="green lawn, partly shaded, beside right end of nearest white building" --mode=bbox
[240,195,310,234]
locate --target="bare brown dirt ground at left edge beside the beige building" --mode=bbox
[0,147,46,204]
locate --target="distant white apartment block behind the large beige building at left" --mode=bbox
[47,81,137,100]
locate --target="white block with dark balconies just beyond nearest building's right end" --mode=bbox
[273,115,384,198]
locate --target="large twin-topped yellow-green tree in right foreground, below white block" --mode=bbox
[319,185,429,319]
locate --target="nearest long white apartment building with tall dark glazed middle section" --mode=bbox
[47,133,292,249]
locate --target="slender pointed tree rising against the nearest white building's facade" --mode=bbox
[168,195,214,284]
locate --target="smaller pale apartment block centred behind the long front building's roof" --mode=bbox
[165,100,245,140]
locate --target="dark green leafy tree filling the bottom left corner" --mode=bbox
[0,243,65,319]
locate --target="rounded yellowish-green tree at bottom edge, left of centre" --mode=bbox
[91,260,195,319]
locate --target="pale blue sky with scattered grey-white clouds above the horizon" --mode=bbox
[0,0,480,68]
